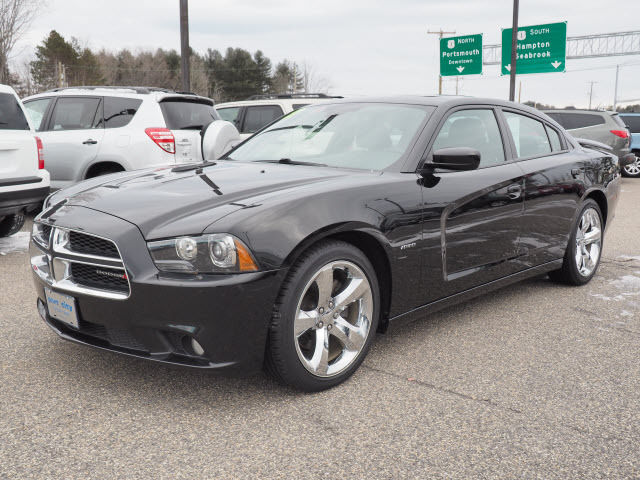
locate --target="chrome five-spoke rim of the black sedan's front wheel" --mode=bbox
[294,261,373,377]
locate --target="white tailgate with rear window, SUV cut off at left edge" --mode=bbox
[0,92,38,180]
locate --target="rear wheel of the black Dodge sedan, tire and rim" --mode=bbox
[549,199,604,285]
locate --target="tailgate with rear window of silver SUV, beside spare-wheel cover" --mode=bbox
[160,97,220,163]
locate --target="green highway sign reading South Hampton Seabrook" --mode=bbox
[501,22,567,75]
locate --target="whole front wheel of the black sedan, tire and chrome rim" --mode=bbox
[265,241,380,392]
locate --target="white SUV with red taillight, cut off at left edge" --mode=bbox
[0,85,49,237]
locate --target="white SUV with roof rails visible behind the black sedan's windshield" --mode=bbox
[215,93,342,140]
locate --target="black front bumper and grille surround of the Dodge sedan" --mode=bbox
[31,206,284,373]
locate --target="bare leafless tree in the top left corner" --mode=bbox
[0,0,44,83]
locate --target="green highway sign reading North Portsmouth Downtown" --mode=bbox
[440,34,482,77]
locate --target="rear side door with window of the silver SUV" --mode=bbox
[38,96,104,188]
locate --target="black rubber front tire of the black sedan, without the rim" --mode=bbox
[265,240,380,392]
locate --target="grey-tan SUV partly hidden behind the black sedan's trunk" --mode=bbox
[544,109,633,176]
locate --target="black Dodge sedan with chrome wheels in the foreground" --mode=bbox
[30,97,620,391]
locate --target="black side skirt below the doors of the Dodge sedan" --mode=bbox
[389,258,562,326]
